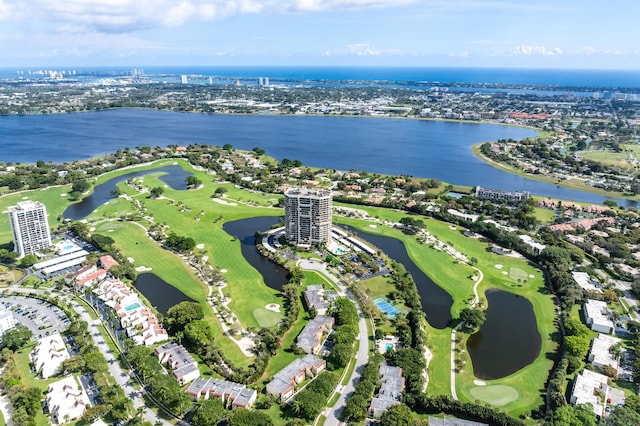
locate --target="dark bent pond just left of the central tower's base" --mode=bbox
[222,216,289,291]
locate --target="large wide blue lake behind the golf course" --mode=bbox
[0,109,631,205]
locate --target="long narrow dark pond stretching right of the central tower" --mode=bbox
[347,226,453,329]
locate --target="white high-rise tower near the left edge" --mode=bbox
[8,201,51,257]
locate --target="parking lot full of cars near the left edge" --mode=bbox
[0,295,70,338]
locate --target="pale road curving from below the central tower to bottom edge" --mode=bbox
[298,260,369,426]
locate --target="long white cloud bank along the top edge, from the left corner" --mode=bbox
[0,0,418,32]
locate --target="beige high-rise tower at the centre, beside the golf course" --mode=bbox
[284,188,332,247]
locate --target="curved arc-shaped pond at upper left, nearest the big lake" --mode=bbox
[62,165,193,220]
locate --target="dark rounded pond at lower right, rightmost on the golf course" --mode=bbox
[467,289,542,380]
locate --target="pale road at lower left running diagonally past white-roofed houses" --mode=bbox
[12,287,178,425]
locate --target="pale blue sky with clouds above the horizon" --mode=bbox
[0,0,640,69]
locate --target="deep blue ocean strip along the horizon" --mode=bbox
[0,66,640,92]
